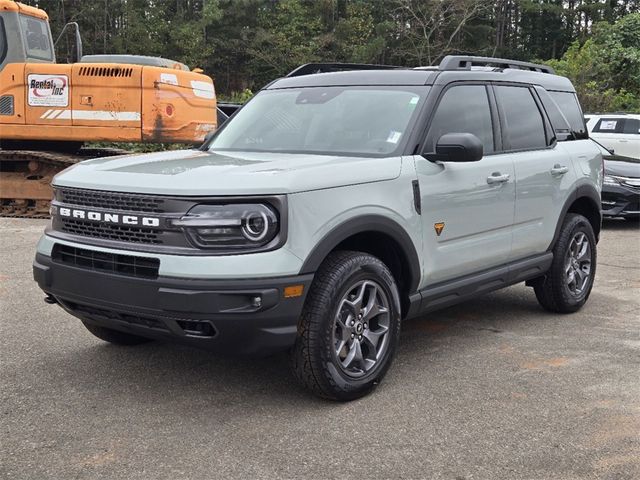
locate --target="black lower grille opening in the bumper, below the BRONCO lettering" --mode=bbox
[51,243,160,278]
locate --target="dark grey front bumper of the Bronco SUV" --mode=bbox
[33,253,313,355]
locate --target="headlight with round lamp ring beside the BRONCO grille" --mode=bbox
[171,203,279,250]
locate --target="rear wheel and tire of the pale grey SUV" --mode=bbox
[533,213,597,313]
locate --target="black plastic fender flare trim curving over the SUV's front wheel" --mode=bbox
[300,215,422,292]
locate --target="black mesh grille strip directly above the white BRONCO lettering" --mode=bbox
[56,188,165,213]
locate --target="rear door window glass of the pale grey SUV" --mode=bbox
[495,86,547,150]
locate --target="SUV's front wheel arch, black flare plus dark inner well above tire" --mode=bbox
[300,215,421,312]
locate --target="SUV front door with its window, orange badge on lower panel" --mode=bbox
[415,85,515,287]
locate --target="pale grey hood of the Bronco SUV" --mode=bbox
[53,150,401,196]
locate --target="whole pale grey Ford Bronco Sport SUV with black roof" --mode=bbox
[34,56,602,400]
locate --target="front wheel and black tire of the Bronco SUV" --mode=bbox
[290,251,400,401]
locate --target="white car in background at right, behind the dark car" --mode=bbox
[585,113,640,158]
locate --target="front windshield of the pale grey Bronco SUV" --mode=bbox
[209,87,428,156]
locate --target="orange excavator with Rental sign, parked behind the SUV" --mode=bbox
[0,0,217,217]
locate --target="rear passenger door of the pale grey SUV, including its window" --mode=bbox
[493,85,576,260]
